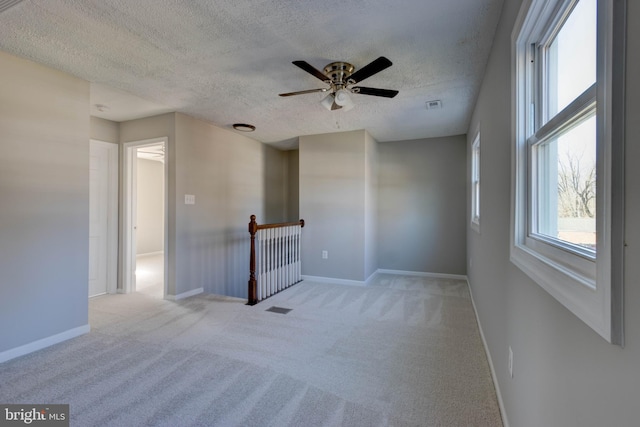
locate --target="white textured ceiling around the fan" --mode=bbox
[0,0,503,148]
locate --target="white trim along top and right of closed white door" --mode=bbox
[89,138,120,294]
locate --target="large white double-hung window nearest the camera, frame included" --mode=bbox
[511,0,625,344]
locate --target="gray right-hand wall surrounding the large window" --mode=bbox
[468,0,640,427]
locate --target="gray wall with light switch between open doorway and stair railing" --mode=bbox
[174,114,284,298]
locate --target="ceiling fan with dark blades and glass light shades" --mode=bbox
[280,56,398,111]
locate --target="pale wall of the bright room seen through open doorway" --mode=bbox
[136,158,164,255]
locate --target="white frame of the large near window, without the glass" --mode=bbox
[510,0,626,345]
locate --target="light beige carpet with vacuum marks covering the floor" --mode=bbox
[0,275,502,426]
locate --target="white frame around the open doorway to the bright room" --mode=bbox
[118,137,169,297]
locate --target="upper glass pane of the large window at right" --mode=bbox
[547,0,596,120]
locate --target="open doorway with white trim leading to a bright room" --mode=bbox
[122,138,168,298]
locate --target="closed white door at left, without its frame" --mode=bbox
[89,141,117,297]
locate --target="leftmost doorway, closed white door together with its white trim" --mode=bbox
[88,140,118,297]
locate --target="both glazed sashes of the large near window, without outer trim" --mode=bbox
[528,0,597,257]
